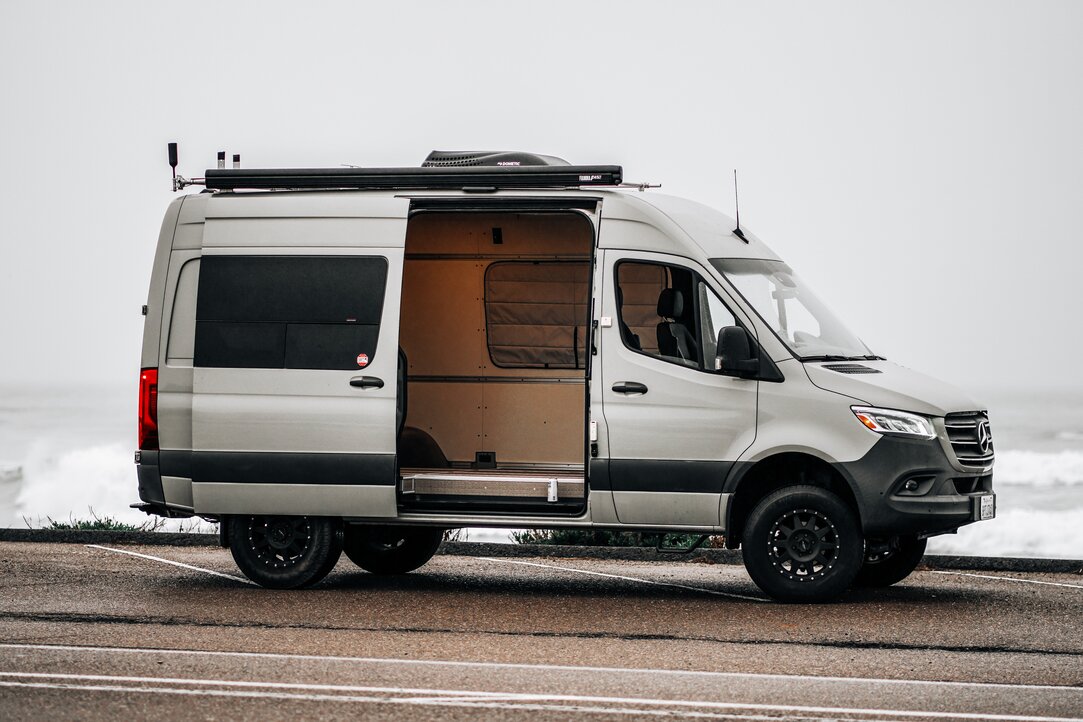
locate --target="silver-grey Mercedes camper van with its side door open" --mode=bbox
[134,152,995,602]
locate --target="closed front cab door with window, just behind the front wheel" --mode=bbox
[591,250,757,528]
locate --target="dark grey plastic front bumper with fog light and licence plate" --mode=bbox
[835,436,995,537]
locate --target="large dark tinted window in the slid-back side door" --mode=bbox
[194,255,388,369]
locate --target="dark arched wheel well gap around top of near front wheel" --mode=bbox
[726,452,861,549]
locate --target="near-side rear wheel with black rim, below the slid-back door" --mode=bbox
[227,516,342,589]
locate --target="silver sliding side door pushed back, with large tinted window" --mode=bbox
[191,196,408,517]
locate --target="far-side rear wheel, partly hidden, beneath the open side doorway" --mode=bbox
[343,525,444,574]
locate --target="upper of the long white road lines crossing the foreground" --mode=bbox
[0,643,1083,695]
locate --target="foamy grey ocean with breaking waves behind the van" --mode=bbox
[0,388,1083,559]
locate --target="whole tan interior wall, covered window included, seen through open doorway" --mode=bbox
[400,212,593,469]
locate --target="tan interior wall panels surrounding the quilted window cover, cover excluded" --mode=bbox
[400,213,593,467]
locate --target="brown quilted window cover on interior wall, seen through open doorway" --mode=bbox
[485,261,590,368]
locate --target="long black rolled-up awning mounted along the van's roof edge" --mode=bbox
[205,166,624,191]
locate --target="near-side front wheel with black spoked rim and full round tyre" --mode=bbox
[741,486,864,602]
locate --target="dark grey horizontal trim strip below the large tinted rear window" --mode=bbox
[159,451,397,486]
